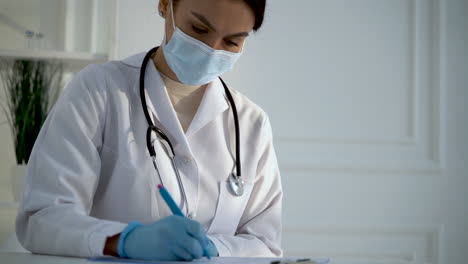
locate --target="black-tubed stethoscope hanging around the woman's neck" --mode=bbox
[140,47,244,216]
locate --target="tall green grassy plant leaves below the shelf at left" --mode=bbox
[0,60,63,164]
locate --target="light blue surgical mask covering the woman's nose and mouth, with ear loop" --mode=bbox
[162,0,242,85]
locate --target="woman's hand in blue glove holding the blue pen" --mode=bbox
[119,215,218,261]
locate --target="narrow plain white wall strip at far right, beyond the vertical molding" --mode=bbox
[439,0,468,263]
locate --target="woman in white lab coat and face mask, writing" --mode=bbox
[16,0,282,260]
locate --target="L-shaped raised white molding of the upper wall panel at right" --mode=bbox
[275,0,445,175]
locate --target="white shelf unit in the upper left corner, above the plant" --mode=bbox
[0,0,117,68]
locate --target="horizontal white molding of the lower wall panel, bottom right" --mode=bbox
[283,225,443,264]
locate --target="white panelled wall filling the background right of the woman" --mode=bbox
[227,0,468,264]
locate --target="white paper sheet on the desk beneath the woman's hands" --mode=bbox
[88,257,329,264]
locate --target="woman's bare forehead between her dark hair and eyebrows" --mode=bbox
[176,0,255,32]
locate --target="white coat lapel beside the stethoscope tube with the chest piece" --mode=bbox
[187,79,228,137]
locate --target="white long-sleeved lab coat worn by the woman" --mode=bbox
[16,54,282,257]
